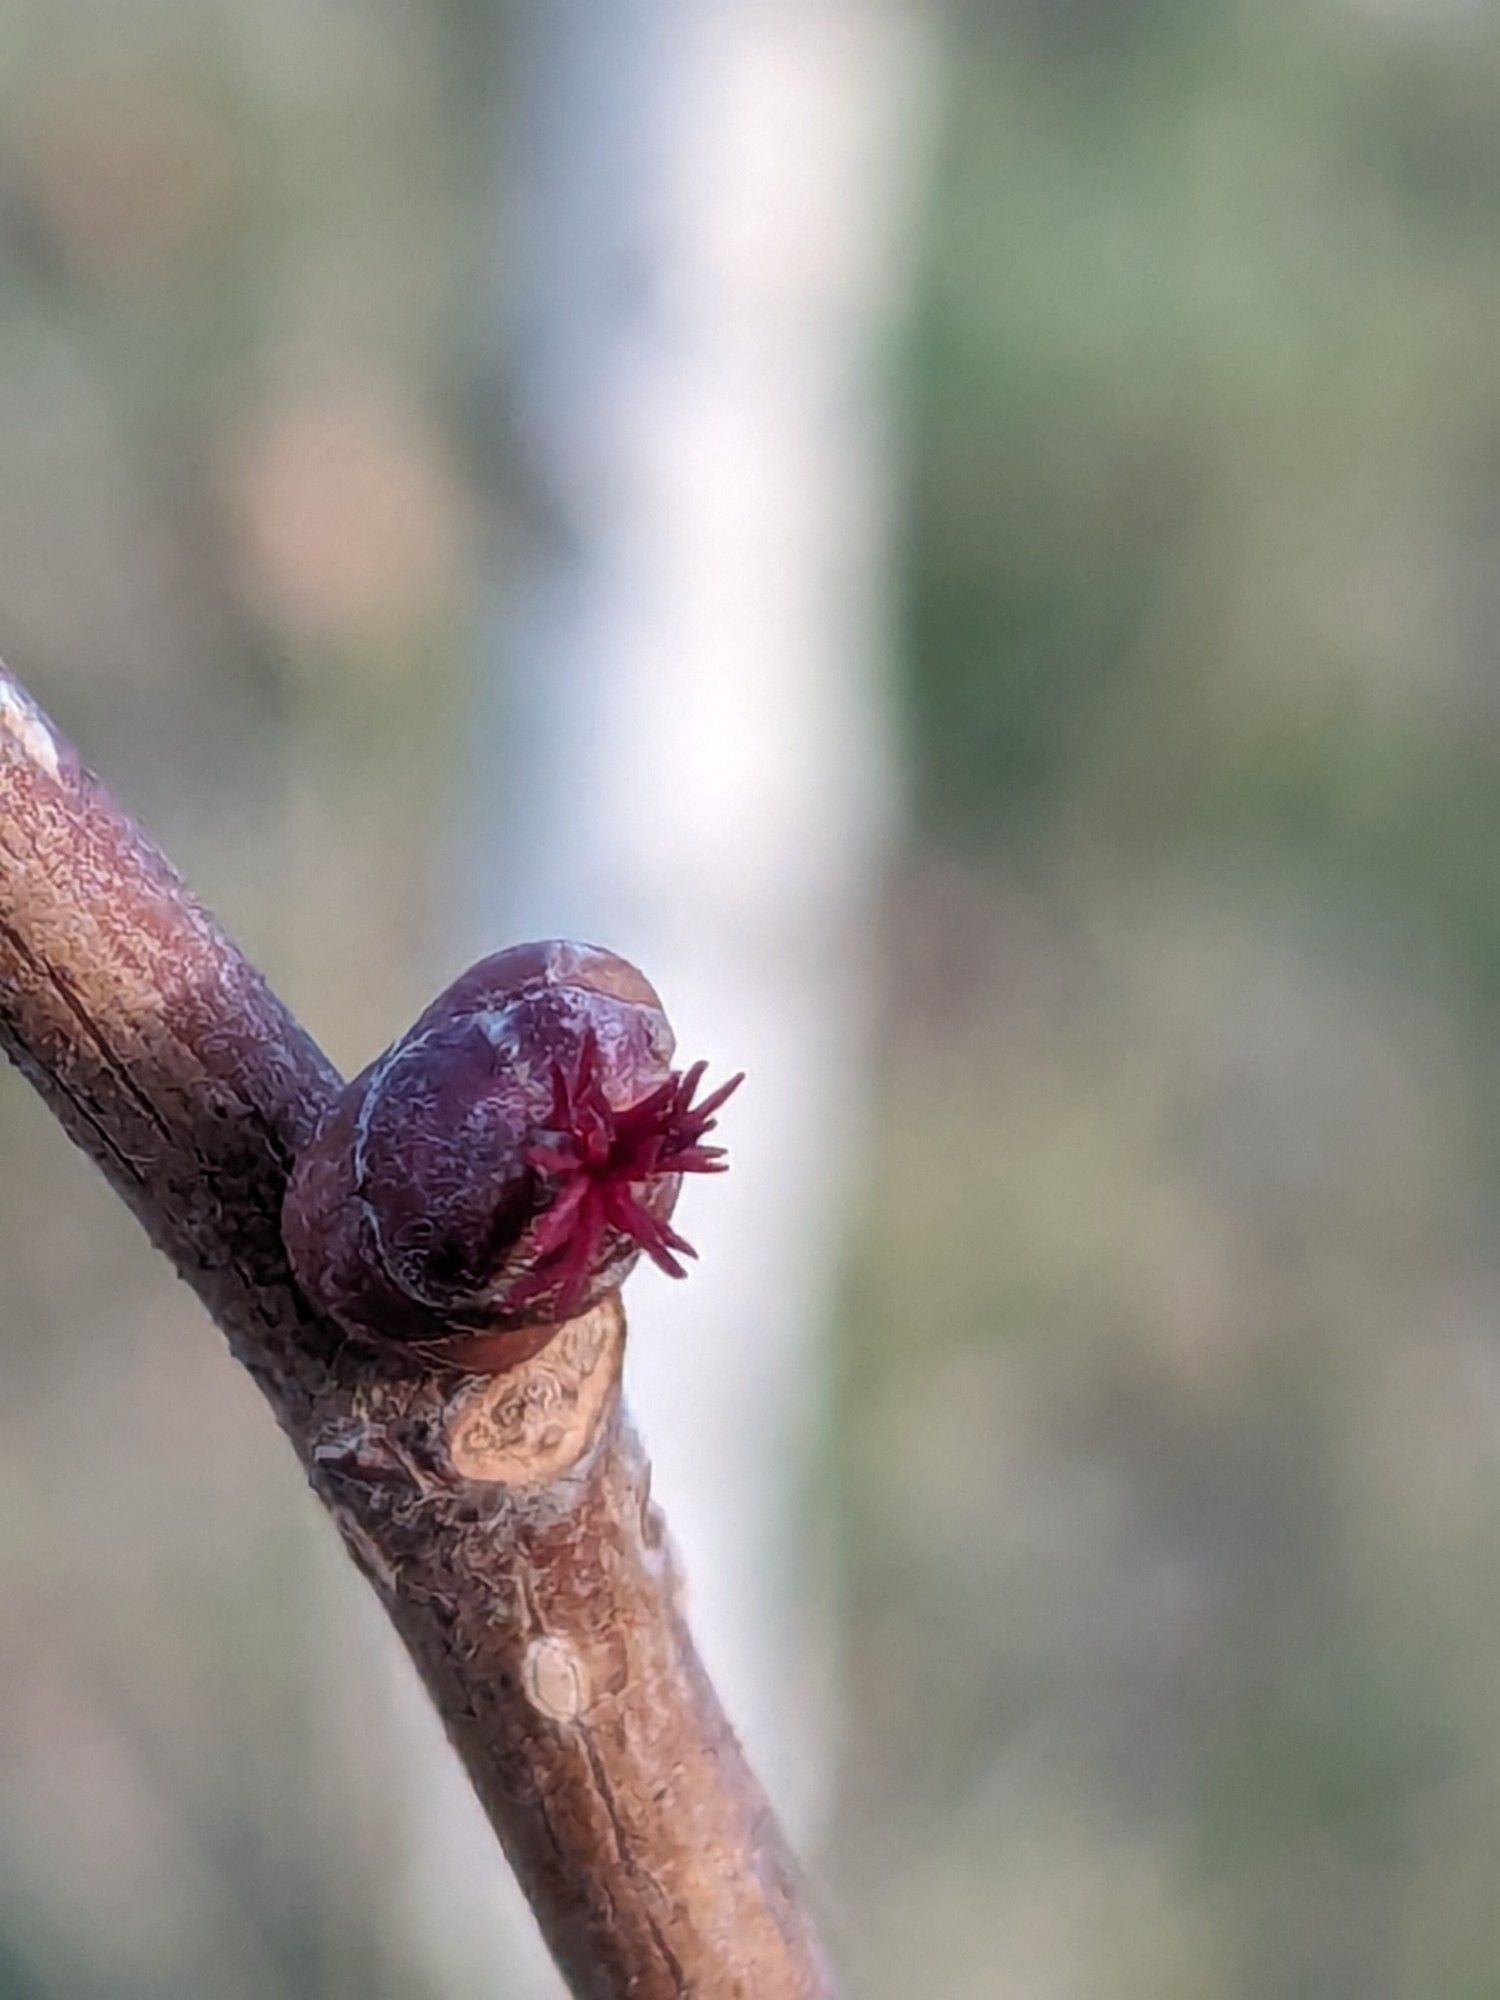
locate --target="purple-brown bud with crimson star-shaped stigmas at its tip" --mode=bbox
[282,942,740,1366]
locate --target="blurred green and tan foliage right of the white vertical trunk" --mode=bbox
[842,0,1500,2000]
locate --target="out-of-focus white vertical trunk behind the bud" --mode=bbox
[434,0,930,1992]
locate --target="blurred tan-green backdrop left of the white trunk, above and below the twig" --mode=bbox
[0,15,496,2000]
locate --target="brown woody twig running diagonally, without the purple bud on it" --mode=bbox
[0,668,832,2000]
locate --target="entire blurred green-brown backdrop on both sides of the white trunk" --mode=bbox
[0,0,1500,2000]
